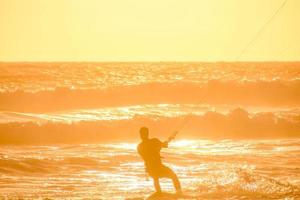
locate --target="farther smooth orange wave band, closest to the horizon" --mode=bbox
[0,80,300,112]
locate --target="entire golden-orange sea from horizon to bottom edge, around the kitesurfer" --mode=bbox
[0,62,300,200]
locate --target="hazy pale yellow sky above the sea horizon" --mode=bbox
[0,0,300,61]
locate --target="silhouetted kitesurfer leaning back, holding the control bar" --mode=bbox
[137,127,182,194]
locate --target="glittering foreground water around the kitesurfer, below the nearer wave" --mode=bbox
[0,139,300,199]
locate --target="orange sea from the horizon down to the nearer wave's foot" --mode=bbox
[0,62,300,144]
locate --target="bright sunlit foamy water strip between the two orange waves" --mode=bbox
[0,104,300,124]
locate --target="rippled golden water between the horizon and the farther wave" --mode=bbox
[0,62,300,92]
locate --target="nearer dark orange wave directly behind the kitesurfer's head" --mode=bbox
[0,108,300,144]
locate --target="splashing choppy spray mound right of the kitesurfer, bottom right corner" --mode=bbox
[197,170,300,200]
